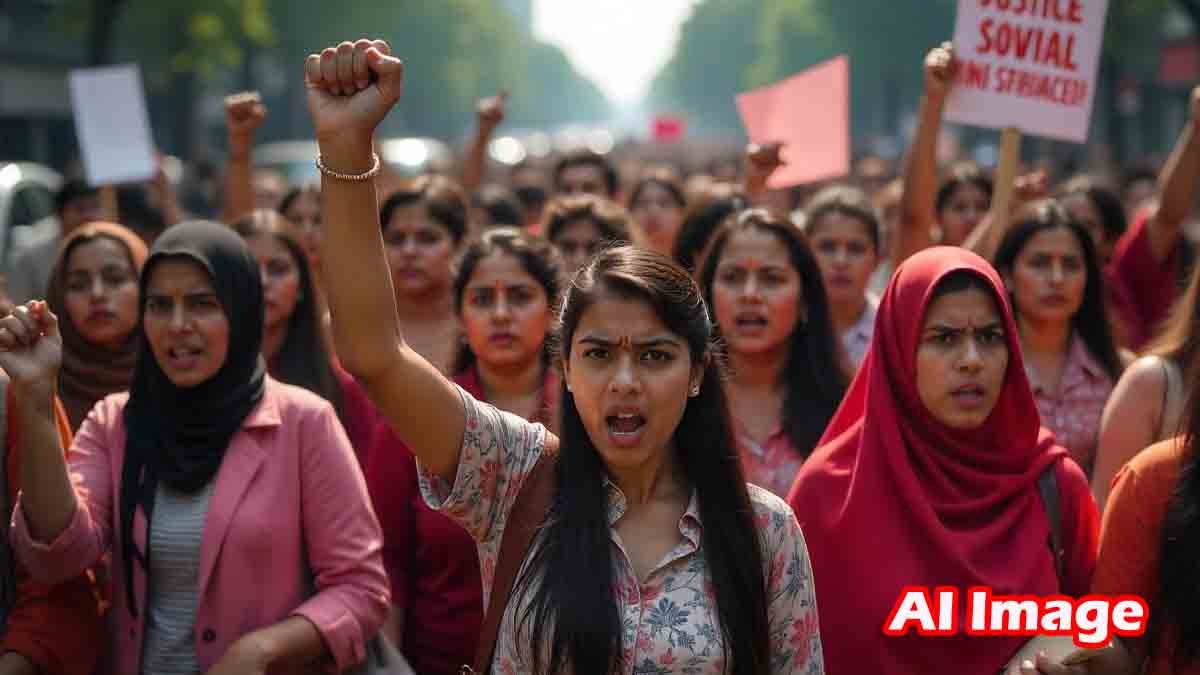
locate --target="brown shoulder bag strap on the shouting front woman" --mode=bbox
[462,431,558,674]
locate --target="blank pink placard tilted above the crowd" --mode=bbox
[737,55,850,189]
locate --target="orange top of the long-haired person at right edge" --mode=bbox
[1092,438,1200,675]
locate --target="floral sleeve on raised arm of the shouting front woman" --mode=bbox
[416,386,546,550]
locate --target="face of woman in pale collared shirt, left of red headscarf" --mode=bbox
[809,211,880,307]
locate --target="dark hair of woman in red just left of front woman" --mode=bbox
[451,227,563,372]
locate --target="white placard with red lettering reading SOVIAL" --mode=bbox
[944,0,1108,143]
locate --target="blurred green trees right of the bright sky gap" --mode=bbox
[650,0,1176,151]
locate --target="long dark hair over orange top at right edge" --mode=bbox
[1146,368,1200,671]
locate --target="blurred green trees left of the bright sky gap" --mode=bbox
[60,0,608,148]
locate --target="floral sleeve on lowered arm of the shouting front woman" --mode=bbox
[749,485,824,675]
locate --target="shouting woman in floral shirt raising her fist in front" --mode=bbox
[306,40,824,675]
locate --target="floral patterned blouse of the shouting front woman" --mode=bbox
[420,388,824,675]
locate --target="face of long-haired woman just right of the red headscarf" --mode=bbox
[1006,227,1087,323]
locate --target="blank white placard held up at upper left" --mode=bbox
[71,65,156,186]
